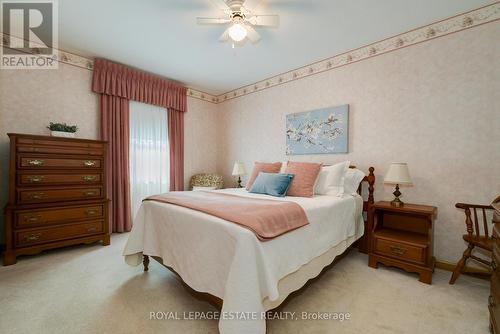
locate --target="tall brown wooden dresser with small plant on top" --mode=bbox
[3,133,110,265]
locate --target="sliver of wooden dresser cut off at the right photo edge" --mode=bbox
[488,210,500,334]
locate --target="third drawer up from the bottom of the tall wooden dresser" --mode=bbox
[17,187,103,204]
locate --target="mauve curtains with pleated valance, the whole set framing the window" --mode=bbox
[92,59,187,232]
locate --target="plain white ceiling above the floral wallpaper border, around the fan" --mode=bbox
[59,0,494,94]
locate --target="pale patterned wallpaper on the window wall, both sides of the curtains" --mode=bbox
[0,63,218,244]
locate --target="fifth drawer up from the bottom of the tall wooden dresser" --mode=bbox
[17,155,102,169]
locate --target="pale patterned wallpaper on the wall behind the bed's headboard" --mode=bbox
[217,22,500,262]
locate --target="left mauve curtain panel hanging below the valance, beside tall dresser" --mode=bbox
[99,94,132,232]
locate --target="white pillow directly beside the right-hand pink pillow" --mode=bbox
[314,161,351,196]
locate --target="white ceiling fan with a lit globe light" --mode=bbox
[196,0,279,48]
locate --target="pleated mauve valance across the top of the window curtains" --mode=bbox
[92,59,187,112]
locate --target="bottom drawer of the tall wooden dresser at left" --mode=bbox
[15,220,104,247]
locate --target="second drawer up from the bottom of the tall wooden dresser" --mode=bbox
[15,204,104,228]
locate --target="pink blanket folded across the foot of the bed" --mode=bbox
[145,191,309,241]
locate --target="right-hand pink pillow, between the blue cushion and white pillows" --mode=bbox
[286,161,322,197]
